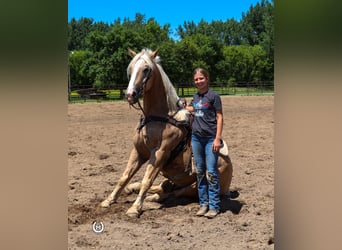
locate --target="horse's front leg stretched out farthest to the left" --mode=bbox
[100,148,143,207]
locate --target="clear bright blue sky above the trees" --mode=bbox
[68,0,261,31]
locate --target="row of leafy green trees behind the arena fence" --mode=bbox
[68,0,274,89]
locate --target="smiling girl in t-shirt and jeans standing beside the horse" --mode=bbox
[186,68,223,218]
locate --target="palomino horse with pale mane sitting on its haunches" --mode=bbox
[100,49,233,217]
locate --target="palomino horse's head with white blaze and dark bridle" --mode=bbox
[126,49,159,104]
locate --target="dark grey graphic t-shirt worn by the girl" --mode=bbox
[190,90,222,137]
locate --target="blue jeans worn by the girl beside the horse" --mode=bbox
[191,134,220,210]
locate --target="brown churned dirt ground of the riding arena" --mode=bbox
[68,96,274,250]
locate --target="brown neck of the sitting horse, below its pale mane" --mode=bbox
[143,74,169,116]
